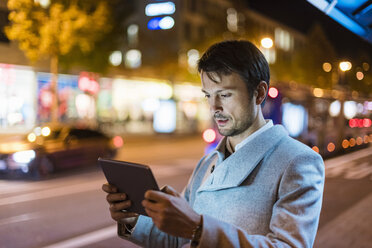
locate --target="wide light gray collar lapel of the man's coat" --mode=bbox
[197,125,288,192]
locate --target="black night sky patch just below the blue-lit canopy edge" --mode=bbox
[247,0,372,58]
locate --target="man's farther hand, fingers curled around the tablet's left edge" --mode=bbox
[102,183,138,224]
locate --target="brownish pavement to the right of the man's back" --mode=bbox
[314,146,372,248]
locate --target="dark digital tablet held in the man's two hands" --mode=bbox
[98,158,159,215]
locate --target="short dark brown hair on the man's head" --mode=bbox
[198,40,270,105]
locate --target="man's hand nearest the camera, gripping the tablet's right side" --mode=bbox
[142,186,201,239]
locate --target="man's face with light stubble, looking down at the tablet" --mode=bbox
[201,72,257,136]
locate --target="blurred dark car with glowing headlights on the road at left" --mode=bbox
[0,125,123,179]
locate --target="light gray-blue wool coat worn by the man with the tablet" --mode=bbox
[125,125,324,247]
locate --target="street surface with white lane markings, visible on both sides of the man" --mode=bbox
[0,136,372,248]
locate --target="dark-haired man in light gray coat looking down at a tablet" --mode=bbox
[103,41,324,247]
